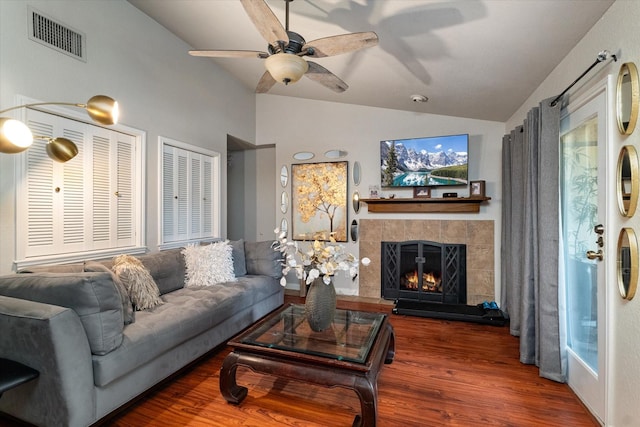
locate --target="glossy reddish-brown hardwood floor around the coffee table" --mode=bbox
[2,296,599,427]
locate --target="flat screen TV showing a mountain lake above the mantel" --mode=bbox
[380,134,469,187]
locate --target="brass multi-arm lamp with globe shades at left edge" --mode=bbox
[0,95,119,162]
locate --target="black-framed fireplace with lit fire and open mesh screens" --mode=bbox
[381,240,467,304]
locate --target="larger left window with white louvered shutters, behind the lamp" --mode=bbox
[16,109,144,268]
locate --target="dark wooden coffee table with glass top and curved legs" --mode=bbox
[220,304,395,426]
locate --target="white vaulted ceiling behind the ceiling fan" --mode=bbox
[129,0,613,121]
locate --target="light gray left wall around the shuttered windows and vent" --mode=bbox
[0,0,255,274]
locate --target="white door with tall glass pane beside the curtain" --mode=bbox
[560,88,612,421]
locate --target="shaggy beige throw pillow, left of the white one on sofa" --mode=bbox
[112,255,162,310]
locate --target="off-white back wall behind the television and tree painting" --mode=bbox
[256,95,505,301]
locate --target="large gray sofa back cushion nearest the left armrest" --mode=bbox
[0,272,124,355]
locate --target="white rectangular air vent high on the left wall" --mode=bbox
[29,8,87,62]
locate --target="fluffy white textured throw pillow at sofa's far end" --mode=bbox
[182,241,236,288]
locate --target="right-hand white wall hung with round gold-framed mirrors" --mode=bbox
[507,0,640,427]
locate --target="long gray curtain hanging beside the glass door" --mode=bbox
[500,98,566,382]
